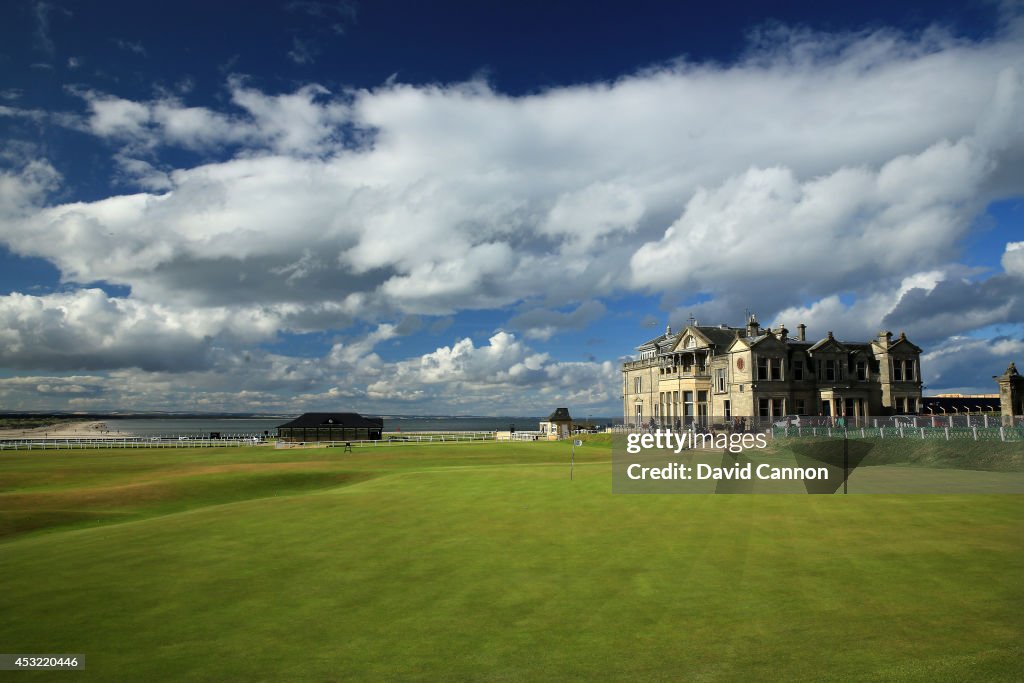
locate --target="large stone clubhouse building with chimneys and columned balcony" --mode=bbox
[623,315,922,427]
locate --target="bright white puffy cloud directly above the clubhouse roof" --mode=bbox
[631,135,992,292]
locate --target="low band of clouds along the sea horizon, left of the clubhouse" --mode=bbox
[0,326,618,415]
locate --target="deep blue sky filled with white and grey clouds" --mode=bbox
[0,0,1024,415]
